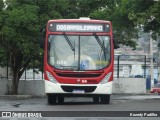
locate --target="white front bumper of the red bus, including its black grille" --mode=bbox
[45,80,112,95]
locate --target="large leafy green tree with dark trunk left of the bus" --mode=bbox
[0,0,77,94]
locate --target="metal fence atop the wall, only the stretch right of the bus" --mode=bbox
[114,55,158,79]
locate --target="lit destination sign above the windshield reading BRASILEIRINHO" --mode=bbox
[48,23,109,32]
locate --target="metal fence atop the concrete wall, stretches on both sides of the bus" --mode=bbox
[0,55,158,80]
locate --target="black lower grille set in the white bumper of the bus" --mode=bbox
[61,85,97,93]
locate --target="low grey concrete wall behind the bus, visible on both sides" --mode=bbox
[0,78,146,96]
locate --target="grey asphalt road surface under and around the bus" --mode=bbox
[0,95,160,120]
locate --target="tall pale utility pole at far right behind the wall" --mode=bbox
[149,31,154,89]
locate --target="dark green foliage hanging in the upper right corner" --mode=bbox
[129,0,160,35]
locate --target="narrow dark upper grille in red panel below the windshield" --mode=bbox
[56,73,101,78]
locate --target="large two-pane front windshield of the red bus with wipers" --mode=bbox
[48,34,111,71]
